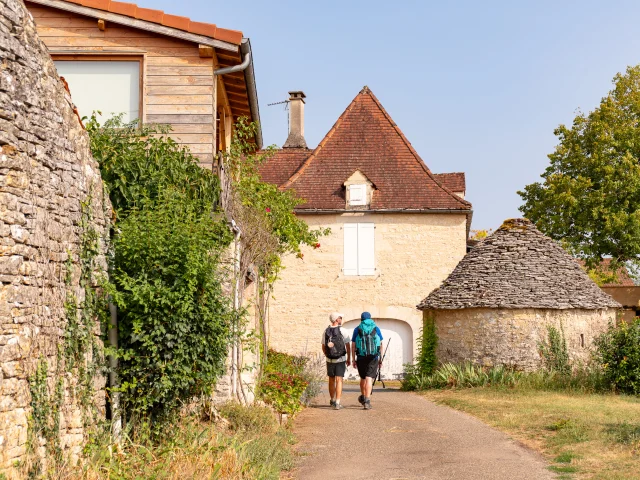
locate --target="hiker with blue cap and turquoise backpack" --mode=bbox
[351,312,382,410]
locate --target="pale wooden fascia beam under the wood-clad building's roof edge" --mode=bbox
[24,0,239,52]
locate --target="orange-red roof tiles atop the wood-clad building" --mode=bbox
[58,0,242,45]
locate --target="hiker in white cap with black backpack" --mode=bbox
[322,312,351,410]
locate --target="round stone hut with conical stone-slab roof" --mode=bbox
[418,218,620,370]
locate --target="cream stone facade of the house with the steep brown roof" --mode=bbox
[269,213,466,354]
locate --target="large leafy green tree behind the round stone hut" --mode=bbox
[518,65,640,272]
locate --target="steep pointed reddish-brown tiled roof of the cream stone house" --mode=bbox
[265,87,471,211]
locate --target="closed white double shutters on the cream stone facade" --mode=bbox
[343,223,376,276]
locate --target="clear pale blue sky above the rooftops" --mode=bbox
[137,0,640,229]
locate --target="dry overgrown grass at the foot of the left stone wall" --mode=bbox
[31,404,294,480]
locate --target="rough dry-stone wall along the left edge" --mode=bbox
[0,0,110,476]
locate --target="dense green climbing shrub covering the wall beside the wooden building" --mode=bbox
[87,118,236,425]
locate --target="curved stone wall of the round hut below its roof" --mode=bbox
[424,308,617,370]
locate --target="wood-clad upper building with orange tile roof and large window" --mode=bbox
[25,0,262,168]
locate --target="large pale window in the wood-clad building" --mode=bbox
[55,59,141,123]
